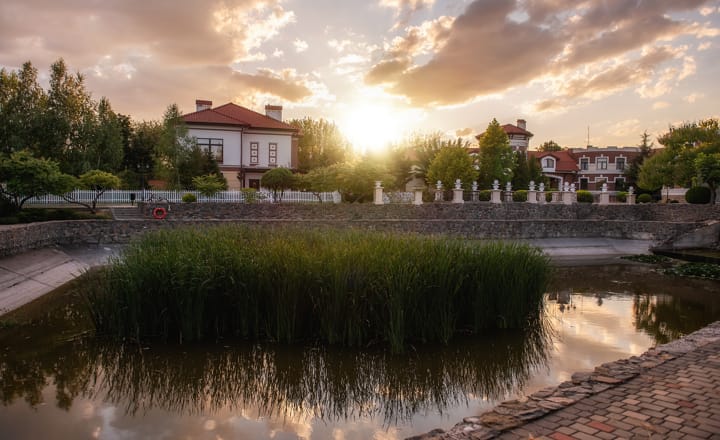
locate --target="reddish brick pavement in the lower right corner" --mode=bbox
[495,342,720,440]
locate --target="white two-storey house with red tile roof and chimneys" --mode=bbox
[183,100,299,189]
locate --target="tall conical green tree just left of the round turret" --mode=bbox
[479,119,514,188]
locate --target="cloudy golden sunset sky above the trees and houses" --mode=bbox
[0,0,720,150]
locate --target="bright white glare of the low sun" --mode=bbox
[340,103,406,153]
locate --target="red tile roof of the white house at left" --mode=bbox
[183,103,298,132]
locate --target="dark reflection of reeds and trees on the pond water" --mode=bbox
[0,323,548,426]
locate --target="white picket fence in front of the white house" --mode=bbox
[26,189,341,205]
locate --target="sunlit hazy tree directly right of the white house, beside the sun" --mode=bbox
[288,118,350,172]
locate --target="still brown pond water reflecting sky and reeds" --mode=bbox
[0,265,720,440]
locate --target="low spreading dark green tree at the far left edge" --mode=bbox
[0,150,75,211]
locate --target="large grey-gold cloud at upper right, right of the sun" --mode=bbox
[365,0,718,109]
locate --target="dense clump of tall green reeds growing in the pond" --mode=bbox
[87,226,549,351]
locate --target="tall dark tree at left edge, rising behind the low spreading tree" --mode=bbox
[0,61,47,154]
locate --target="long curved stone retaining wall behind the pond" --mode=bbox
[0,203,720,257]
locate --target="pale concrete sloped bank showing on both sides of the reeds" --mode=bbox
[0,238,654,315]
